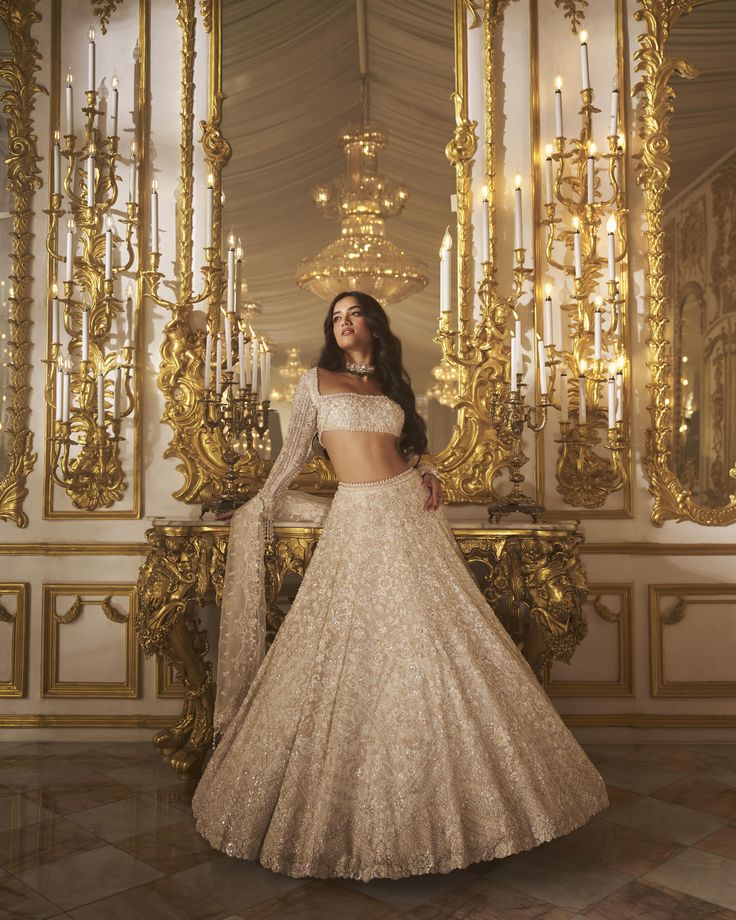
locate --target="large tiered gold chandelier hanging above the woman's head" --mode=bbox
[297,0,427,304]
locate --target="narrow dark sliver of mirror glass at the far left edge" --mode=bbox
[0,26,13,481]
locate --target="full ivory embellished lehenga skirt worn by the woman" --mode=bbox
[192,469,608,881]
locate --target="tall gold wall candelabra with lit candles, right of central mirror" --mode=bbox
[541,32,628,508]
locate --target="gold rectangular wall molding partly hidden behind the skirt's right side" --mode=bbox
[545,584,634,697]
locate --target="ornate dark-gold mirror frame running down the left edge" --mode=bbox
[0,0,46,527]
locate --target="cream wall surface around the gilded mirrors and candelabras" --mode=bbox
[0,0,736,740]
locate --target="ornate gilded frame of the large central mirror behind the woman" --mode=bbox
[158,0,486,504]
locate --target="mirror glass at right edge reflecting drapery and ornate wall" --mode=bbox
[664,0,736,508]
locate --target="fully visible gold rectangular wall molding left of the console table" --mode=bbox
[41,582,141,699]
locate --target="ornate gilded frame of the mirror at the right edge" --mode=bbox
[633,0,736,527]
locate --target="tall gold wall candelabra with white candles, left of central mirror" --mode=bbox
[44,30,138,511]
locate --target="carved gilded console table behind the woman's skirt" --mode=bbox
[135,518,587,773]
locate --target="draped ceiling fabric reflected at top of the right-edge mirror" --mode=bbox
[667,0,736,203]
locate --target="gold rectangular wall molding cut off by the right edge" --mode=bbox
[649,584,736,699]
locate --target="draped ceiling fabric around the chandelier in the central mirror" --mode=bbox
[222,0,454,393]
